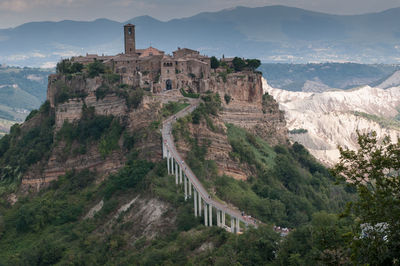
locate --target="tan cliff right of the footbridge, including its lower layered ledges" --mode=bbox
[177,72,288,180]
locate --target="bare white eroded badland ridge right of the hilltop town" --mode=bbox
[263,77,400,165]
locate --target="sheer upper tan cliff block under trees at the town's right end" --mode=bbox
[208,72,287,145]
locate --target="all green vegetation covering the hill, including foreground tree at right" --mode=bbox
[0,79,400,265]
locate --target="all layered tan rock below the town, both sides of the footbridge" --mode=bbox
[22,72,287,190]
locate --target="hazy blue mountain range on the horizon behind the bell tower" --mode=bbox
[0,6,400,66]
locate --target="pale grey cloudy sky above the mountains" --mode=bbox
[0,0,400,28]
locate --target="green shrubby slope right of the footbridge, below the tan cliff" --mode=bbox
[173,94,349,227]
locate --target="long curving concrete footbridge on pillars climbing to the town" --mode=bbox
[162,98,258,233]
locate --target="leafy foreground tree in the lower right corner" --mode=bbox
[332,132,400,265]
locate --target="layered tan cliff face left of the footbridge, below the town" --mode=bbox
[22,75,162,190]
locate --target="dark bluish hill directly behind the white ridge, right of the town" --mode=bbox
[259,63,400,92]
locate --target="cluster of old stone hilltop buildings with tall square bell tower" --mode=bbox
[71,24,211,93]
